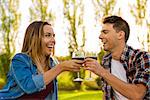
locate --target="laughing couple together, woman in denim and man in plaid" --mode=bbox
[0,16,150,100]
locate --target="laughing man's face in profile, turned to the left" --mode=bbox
[99,23,118,52]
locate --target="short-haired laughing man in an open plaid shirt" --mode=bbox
[85,16,150,100]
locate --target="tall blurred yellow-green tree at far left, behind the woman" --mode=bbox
[0,0,21,87]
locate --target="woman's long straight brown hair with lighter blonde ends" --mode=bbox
[22,21,50,73]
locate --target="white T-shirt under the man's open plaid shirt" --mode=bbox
[111,59,128,100]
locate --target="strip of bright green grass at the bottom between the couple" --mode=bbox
[58,90,103,100]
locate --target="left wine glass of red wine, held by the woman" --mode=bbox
[72,51,84,82]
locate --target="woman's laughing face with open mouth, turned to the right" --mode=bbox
[42,25,55,56]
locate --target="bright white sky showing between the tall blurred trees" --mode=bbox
[16,0,150,56]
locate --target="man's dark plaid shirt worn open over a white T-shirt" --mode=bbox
[102,45,150,100]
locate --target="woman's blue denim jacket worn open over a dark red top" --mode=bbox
[0,53,58,100]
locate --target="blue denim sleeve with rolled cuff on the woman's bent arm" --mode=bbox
[11,54,46,94]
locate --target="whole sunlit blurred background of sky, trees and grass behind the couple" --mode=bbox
[0,0,150,100]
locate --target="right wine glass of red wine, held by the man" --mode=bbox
[85,52,97,81]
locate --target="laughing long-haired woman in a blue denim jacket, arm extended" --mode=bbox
[0,21,83,100]
